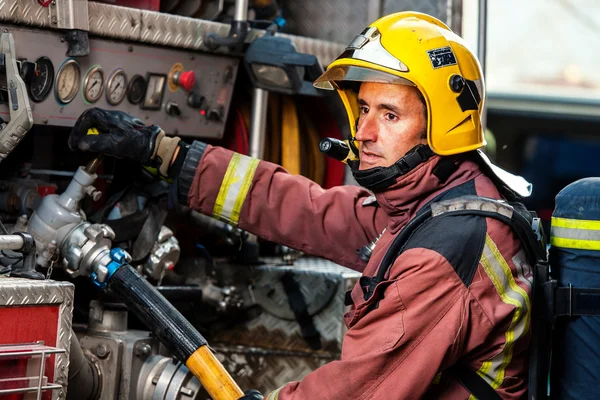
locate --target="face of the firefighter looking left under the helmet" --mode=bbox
[356,82,427,170]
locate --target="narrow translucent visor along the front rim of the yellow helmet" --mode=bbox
[313,65,416,90]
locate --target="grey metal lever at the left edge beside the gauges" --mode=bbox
[0,33,33,162]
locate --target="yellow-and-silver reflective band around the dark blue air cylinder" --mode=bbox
[550,217,600,250]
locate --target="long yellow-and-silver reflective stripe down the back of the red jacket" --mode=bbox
[477,235,531,389]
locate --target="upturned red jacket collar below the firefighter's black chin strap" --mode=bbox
[375,155,482,234]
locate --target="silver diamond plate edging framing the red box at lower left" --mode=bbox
[0,278,75,399]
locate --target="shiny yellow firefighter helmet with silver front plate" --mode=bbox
[314,12,486,156]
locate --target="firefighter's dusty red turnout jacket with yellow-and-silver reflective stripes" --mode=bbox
[178,142,532,400]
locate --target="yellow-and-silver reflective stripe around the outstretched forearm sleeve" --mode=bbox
[213,153,259,225]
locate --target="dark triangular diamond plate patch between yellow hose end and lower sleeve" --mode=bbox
[211,345,337,394]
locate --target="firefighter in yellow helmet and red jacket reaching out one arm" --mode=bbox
[69,12,531,400]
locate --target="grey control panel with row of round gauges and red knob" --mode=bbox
[0,25,240,138]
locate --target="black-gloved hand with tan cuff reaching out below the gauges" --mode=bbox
[68,108,180,176]
